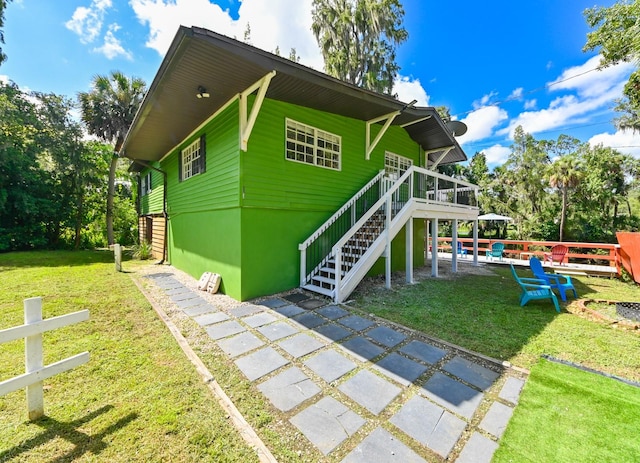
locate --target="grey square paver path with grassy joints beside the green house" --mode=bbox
[148,272,526,463]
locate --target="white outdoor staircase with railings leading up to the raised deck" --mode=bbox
[298,167,478,302]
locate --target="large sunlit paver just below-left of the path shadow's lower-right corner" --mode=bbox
[389,396,467,458]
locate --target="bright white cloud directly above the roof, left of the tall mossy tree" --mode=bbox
[130,0,324,70]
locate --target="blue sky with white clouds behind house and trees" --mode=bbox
[0,0,640,165]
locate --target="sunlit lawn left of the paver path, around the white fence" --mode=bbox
[0,252,257,462]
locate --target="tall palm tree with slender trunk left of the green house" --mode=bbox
[78,71,146,245]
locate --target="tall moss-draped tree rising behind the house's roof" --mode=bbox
[312,0,408,94]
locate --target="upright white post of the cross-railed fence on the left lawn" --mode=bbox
[24,297,44,421]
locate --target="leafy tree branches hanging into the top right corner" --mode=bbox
[584,0,640,132]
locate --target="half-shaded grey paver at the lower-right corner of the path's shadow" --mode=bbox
[421,373,484,419]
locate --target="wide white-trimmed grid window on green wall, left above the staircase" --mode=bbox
[285,119,342,170]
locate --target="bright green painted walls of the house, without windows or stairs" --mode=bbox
[156,96,424,300]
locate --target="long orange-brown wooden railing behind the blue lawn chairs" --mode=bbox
[438,237,619,267]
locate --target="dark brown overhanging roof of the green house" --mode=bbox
[121,26,467,164]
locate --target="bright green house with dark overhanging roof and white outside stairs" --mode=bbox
[120,27,478,301]
